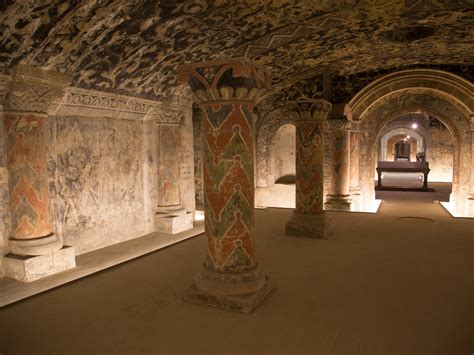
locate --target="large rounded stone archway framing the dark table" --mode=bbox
[349,69,474,215]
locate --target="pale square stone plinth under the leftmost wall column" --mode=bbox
[3,246,76,282]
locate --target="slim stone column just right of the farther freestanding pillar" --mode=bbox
[324,118,351,211]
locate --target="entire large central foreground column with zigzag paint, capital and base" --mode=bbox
[179,58,273,313]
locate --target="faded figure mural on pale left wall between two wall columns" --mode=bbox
[48,117,144,253]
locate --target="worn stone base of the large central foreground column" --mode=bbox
[183,267,274,313]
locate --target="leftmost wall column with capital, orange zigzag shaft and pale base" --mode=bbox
[5,66,75,281]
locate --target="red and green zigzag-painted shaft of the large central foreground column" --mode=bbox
[203,104,256,272]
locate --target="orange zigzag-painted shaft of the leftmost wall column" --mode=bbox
[5,114,52,239]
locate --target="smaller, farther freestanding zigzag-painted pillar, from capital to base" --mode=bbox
[286,99,331,239]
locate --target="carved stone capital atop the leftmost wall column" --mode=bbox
[4,65,70,114]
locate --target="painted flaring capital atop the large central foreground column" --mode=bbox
[178,58,271,105]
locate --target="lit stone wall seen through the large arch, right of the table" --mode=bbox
[426,125,454,182]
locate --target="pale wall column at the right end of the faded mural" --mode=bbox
[155,110,193,234]
